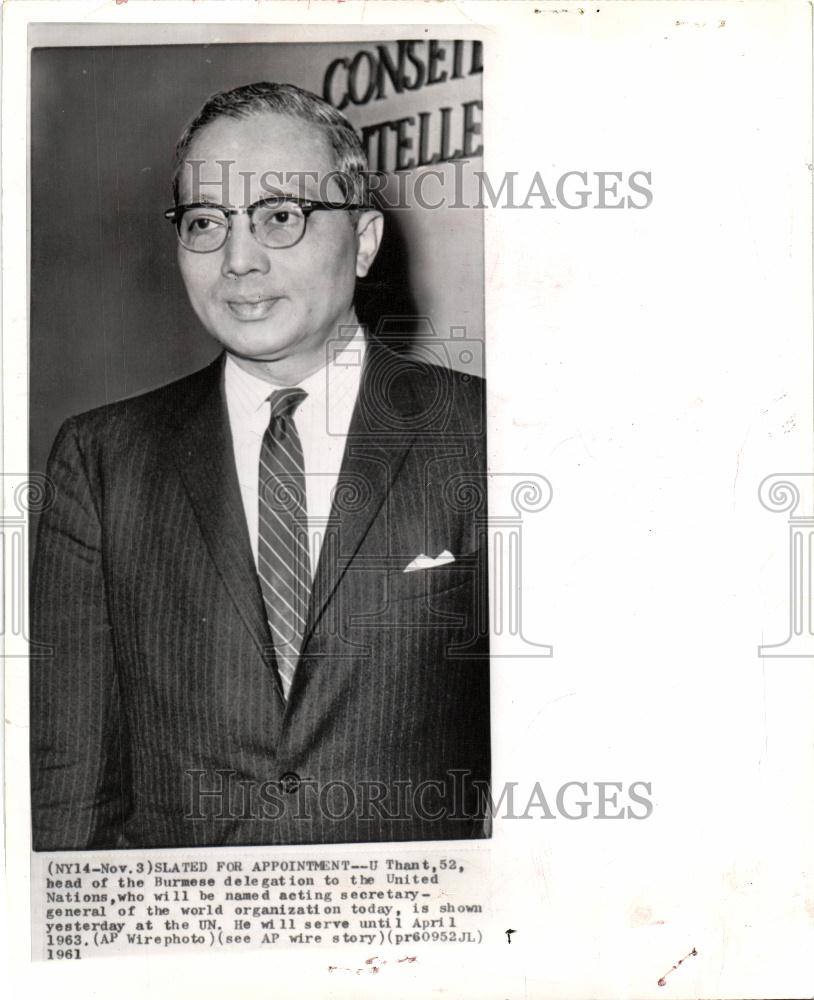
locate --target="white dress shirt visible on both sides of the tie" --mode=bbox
[224,329,366,579]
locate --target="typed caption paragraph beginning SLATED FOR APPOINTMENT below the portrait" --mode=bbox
[32,849,487,961]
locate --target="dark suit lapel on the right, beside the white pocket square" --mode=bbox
[302,341,419,651]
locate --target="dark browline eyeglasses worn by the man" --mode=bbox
[164,196,363,253]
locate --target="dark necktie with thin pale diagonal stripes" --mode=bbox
[257,387,311,699]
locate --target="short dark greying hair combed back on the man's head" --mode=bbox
[172,82,368,205]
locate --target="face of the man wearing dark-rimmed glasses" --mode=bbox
[178,112,381,374]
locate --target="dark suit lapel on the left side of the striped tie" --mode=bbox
[168,357,278,684]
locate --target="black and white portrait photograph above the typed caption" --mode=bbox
[30,38,490,851]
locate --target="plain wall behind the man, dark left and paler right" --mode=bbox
[29,42,483,480]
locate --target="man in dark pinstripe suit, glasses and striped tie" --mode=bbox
[31,84,489,850]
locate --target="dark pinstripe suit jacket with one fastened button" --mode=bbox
[31,344,489,850]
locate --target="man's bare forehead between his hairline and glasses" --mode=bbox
[179,112,336,204]
